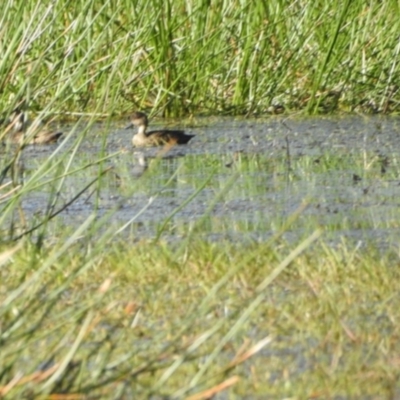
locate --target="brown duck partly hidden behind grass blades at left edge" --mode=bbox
[3,109,63,144]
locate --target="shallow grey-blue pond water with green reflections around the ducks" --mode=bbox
[0,116,400,248]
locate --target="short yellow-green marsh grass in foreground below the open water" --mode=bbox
[0,233,400,399]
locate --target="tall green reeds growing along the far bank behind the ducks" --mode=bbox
[0,0,400,117]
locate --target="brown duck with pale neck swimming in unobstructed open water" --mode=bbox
[125,111,195,147]
